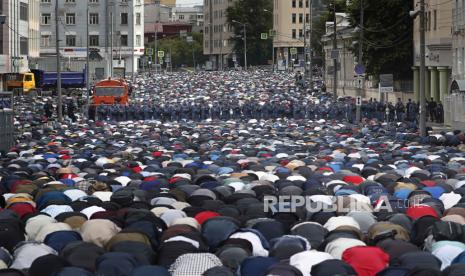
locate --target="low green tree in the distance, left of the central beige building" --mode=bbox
[149,33,208,68]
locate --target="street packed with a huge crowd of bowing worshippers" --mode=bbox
[0,71,465,275]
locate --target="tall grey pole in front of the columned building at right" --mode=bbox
[420,0,426,137]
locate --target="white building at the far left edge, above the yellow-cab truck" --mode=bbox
[0,0,40,76]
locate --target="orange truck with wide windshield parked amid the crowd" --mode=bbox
[92,78,129,105]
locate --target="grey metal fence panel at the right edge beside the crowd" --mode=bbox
[444,93,465,130]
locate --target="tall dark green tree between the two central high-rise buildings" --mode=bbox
[226,0,274,65]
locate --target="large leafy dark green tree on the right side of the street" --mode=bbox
[347,0,413,79]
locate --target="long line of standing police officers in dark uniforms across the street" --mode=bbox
[91,99,442,122]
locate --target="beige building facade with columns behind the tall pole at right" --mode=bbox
[412,0,452,102]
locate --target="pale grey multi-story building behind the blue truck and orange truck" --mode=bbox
[39,0,144,82]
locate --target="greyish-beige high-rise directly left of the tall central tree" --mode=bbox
[203,0,236,69]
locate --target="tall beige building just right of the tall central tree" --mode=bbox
[273,0,324,70]
